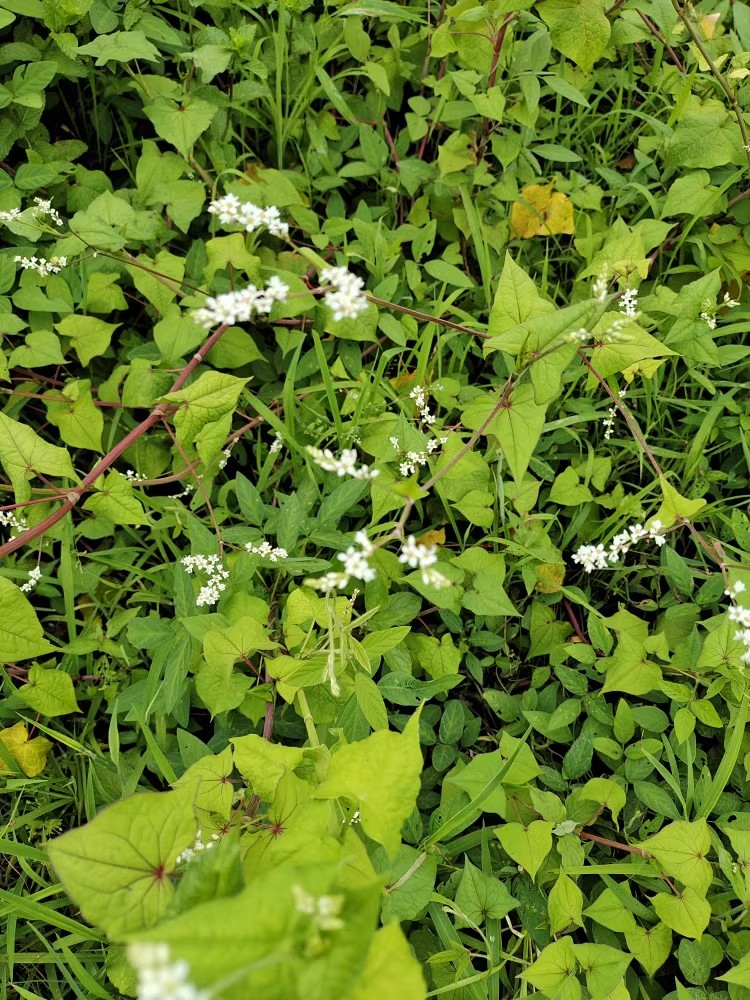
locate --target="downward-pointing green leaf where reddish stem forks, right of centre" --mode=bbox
[461,384,547,483]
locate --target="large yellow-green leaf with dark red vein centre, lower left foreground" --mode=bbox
[47,788,197,938]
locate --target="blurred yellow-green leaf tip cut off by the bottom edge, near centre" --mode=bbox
[351,924,427,1000]
